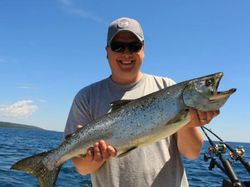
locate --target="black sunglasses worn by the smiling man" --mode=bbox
[110,41,143,53]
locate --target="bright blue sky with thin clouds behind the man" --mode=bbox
[0,0,250,142]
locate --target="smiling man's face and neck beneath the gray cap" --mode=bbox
[106,31,144,84]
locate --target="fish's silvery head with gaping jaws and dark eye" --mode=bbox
[183,72,236,111]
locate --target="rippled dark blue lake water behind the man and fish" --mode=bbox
[0,128,250,187]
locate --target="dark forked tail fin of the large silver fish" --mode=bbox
[11,152,61,187]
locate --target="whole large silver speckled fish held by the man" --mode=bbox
[12,73,236,186]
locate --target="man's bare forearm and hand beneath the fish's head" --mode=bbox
[177,108,219,160]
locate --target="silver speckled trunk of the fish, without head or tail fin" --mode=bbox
[50,83,189,168]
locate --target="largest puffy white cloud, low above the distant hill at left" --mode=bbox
[0,100,38,118]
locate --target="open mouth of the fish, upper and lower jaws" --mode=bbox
[209,72,236,101]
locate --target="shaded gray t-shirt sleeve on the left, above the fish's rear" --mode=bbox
[64,89,91,137]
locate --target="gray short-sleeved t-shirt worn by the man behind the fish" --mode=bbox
[65,74,188,187]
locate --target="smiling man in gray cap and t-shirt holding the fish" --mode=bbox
[65,18,218,187]
